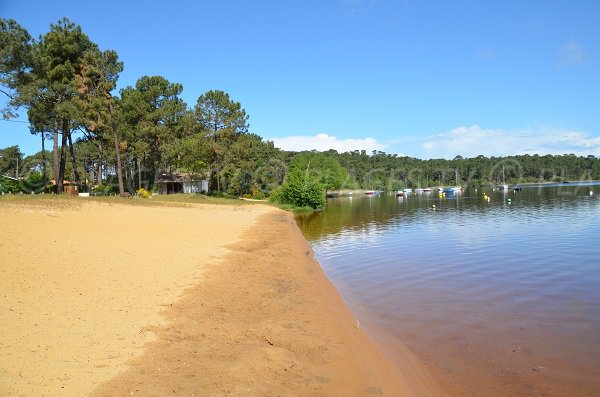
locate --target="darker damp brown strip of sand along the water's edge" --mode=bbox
[93,209,448,396]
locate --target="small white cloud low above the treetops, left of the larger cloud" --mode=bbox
[270,134,388,154]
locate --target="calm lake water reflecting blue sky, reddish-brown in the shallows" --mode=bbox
[297,184,600,397]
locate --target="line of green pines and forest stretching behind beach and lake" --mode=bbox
[0,18,600,207]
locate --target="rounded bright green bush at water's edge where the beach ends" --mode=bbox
[271,168,325,209]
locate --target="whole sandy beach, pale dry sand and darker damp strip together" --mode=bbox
[0,200,444,396]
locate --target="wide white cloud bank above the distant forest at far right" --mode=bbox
[422,125,600,158]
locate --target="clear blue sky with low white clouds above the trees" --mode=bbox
[0,0,600,158]
